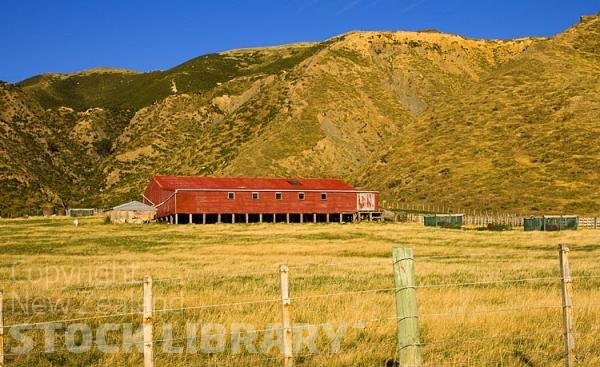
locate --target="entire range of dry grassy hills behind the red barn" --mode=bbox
[0,16,600,215]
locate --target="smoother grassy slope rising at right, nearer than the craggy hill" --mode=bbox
[365,17,600,213]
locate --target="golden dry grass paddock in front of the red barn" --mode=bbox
[0,218,600,366]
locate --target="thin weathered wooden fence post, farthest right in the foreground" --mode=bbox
[559,244,575,367]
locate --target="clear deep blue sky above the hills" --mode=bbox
[0,0,600,82]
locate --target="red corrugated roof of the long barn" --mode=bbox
[152,176,354,191]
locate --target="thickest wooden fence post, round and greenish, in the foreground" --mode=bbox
[392,247,423,367]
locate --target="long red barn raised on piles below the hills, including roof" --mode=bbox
[143,176,380,224]
